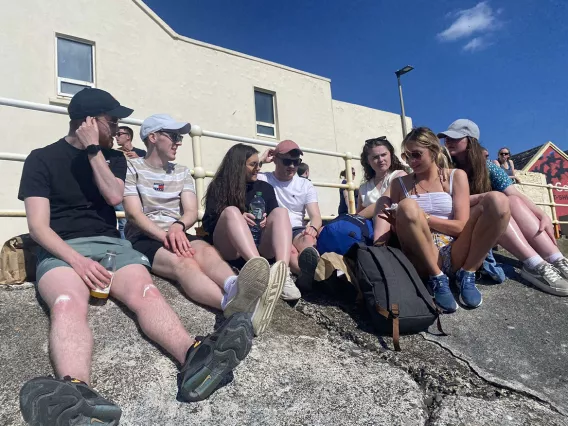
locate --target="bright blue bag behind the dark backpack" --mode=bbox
[317,214,373,255]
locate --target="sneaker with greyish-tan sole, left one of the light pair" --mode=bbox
[223,257,270,318]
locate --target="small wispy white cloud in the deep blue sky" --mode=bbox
[438,1,501,41]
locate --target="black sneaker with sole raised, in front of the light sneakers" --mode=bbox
[178,312,253,402]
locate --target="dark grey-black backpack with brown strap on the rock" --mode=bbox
[345,244,445,351]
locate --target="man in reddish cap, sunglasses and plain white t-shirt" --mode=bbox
[258,140,322,301]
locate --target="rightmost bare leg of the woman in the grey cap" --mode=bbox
[503,196,559,259]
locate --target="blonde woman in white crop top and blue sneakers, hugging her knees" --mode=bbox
[374,127,510,313]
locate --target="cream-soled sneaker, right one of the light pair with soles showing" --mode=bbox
[252,260,288,336]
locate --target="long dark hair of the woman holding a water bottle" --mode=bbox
[205,143,258,214]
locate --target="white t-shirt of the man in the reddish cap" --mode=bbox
[258,172,318,228]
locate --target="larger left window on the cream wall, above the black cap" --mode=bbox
[56,36,95,97]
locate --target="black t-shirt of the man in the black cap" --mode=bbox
[18,139,126,240]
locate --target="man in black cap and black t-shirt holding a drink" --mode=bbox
[18,88,253,425]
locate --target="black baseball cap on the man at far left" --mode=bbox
[67,87,134,120]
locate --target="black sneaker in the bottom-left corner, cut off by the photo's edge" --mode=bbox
[20,376,122,426]
